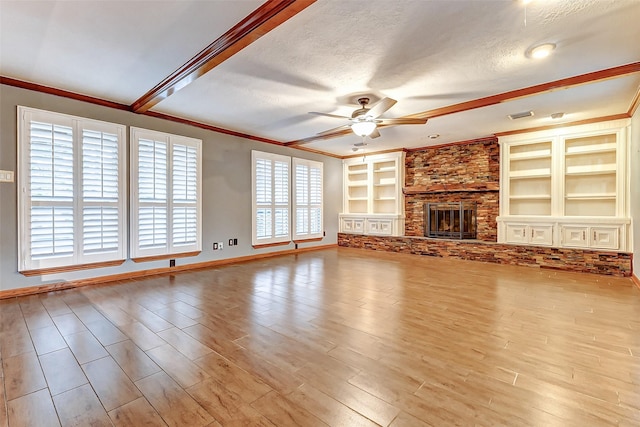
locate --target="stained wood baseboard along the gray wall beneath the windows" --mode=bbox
[0,244,338,300]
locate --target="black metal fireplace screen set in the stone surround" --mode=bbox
[424,202,477,239]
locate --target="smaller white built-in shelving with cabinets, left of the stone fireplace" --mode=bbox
[340,152,404,236]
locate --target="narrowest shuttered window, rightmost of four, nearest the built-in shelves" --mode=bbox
[293,158,323,240]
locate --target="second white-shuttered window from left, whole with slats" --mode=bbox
[131,128,202,259]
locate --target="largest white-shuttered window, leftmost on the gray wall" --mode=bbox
[18,107,126,272]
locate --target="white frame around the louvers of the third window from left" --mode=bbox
[251,150,291,246]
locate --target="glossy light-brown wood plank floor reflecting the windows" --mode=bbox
[0,248,640,427]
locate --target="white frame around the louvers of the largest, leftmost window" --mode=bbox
[17,106,127,271]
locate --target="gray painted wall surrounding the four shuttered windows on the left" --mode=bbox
[0,85,342,291]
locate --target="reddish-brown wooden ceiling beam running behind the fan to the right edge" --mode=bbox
[285,62,640,146]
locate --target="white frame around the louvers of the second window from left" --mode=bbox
[130,127,202,259]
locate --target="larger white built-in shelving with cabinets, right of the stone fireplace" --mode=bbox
[498,120,631,251]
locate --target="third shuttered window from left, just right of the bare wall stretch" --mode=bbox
[251,151,291,245]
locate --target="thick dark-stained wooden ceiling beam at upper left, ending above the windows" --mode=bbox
[131,0,316,113]
